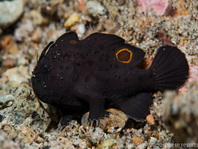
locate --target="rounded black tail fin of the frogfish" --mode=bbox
[149,46,189,91]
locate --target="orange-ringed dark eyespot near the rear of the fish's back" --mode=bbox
[116,49,133,63]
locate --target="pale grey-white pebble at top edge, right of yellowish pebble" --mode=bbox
[86,1,106,17]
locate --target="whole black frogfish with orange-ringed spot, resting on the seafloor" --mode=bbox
[31,32,189,125]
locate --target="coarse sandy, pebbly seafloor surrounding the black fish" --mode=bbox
[0,0,198,149]
